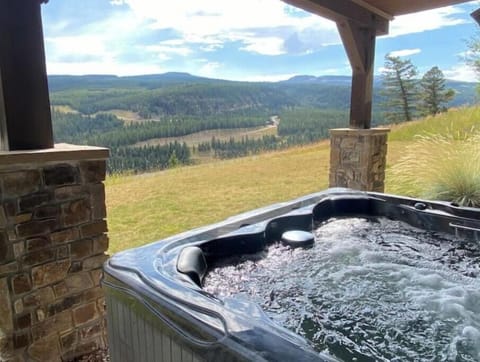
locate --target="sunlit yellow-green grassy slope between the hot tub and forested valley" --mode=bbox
[106,108,480,252]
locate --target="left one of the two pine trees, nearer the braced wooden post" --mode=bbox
[381,55,418,122]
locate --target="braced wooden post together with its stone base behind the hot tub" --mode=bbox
[330,18,388,192]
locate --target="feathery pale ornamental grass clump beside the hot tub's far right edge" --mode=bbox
[388,129,480,207]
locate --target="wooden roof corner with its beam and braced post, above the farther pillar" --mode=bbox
[283,0,474,129]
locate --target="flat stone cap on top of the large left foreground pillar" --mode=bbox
[0,143,110,167]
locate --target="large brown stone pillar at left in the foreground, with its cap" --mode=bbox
[0,145,108,362]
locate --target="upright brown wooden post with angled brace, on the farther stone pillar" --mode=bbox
[337,21,376,129]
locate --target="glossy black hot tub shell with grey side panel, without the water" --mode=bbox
[103,189,480,362]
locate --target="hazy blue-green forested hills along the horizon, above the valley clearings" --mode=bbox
[49,73,475,119]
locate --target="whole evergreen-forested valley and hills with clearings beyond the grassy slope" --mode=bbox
[49,73,475,173]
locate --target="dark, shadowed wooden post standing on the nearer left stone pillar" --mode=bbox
[0,0,53,150]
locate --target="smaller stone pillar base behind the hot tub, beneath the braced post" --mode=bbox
[330,128,390,192]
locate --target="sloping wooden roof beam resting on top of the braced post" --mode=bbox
[283,0,391,35]
